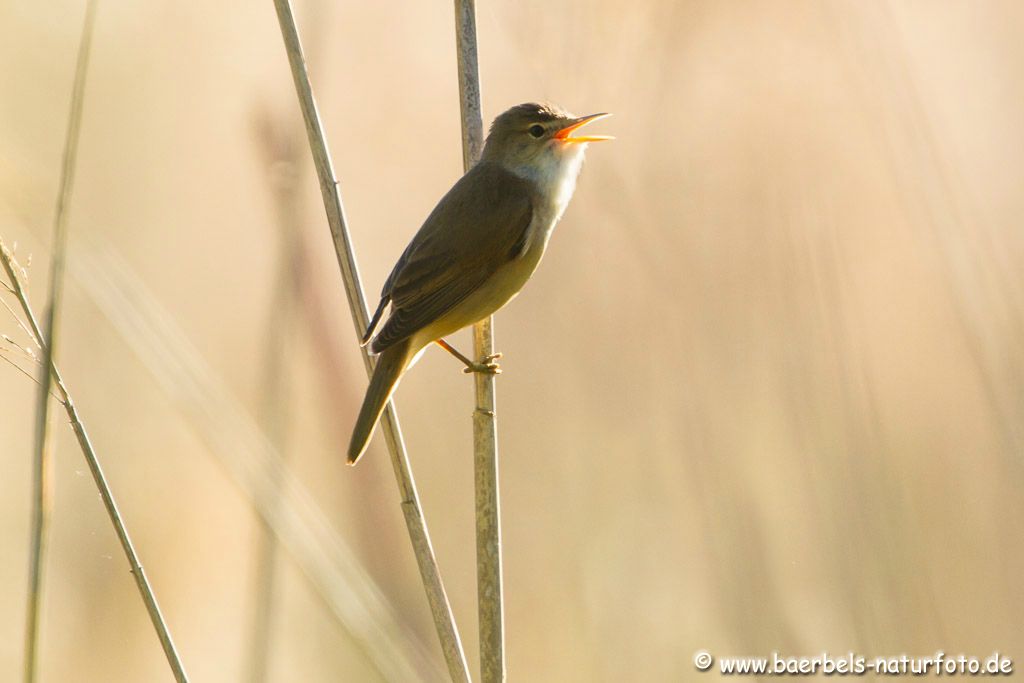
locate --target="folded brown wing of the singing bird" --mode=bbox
[373,162,534,353]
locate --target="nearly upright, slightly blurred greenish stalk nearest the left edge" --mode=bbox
[24,0,96,683]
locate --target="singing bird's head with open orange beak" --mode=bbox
[483,102,613,184]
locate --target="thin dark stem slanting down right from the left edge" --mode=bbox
[0,242,188,683]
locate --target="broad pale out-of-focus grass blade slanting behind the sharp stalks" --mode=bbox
[72,242,444,682]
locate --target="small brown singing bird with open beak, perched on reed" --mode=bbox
[348,102,612,465]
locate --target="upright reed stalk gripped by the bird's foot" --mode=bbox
[455,0,505,683]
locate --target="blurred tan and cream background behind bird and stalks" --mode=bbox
[0,0,1024,682]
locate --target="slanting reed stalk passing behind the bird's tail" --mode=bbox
[273,0,470,683]
